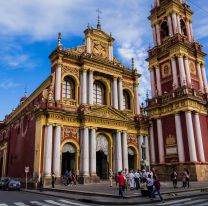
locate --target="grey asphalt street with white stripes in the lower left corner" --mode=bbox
[0,190,97,206]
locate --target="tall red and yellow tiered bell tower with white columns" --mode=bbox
[147,0,208,180]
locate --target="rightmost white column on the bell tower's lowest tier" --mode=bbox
[194,112,205,162]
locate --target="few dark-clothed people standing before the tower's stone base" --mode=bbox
[170,169,190,188]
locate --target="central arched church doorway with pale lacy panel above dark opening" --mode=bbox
[96,134,109,179]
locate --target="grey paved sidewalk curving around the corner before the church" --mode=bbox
[27,182,208,205]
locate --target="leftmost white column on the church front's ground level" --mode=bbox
[44,125,53,176]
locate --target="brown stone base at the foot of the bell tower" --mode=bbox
[151,163,208,181]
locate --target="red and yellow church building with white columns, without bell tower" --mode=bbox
[0,22,150,183]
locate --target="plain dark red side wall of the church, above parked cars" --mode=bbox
[7,115,35,177]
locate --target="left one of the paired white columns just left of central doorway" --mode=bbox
[81,128,89,176]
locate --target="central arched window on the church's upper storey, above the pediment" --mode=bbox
[93,81,105,104]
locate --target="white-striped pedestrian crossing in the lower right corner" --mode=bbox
[157,197,208,206]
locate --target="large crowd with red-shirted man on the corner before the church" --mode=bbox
[112,168,164,202]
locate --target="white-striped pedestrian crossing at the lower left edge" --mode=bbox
[0,199,87,206]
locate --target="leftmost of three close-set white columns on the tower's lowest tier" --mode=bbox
[175,114,185,162]
